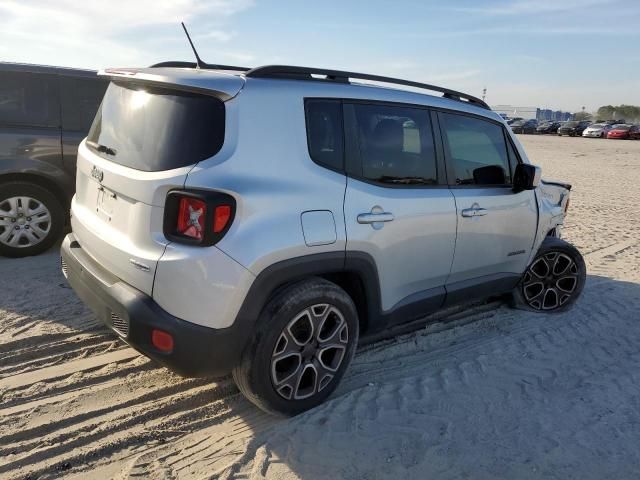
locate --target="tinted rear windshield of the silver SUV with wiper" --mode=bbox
[87,82,225,172]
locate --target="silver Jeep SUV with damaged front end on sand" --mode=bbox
[62,62,585,415]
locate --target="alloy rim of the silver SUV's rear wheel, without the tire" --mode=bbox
[271,303,349,400]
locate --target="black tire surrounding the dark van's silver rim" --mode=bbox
[0,182,65,258]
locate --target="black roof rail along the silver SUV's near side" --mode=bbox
[245,65,491,110]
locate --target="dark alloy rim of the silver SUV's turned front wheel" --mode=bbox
[522,252,579,310]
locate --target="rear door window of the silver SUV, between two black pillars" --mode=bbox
[353,103,437,185]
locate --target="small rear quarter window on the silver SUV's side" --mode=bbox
[305,100,344,171]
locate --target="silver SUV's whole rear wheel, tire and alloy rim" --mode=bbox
[233,278,358,416]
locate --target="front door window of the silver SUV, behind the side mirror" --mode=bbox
[440,113,511,185]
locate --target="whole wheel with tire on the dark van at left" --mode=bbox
[0,182,64,257]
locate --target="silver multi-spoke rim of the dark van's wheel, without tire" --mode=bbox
[0,197,51,248]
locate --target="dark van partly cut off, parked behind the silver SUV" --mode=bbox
[0,62,108,257]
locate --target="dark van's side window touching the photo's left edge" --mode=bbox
[0,72,60,127]
